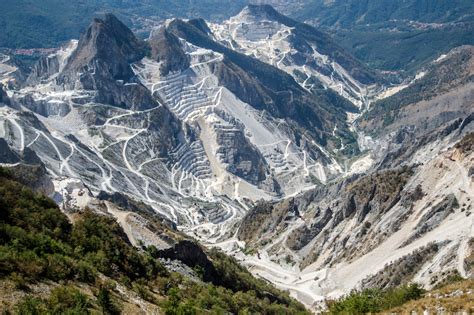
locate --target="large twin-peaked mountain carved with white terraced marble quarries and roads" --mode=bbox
[2,7,374,246]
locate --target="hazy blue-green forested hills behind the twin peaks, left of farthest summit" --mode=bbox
[0,0,248,48]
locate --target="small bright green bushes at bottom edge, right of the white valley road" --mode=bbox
[328,284,424,314]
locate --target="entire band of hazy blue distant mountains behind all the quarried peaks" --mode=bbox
[4,0,474,74]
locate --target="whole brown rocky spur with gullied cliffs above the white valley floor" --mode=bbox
[239,168,412,265]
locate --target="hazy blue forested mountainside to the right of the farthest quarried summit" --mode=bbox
[292,0,474,73]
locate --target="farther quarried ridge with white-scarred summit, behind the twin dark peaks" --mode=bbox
[211,5,383,107]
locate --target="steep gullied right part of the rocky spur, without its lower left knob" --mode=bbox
[287,169,412,265]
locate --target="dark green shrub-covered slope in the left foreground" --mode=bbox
[0,168,307,314]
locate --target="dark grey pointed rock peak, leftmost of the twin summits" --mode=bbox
[56,14,157,110]
